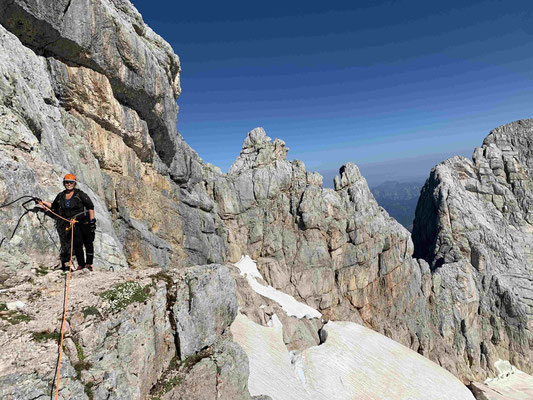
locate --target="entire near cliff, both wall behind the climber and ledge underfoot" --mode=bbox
[0,0,241,400]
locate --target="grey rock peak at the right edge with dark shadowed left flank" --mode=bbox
[413,120,533,373]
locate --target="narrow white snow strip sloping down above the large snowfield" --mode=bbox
[234,256,322,322]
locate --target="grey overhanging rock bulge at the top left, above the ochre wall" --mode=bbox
[0,0,181,168]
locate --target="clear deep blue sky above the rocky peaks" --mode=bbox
[133,0,533,184]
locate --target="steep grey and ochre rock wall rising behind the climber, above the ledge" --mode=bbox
[0,0,225,269]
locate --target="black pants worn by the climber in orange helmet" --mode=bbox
[57,221,94,267]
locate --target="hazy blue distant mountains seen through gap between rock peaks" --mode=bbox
[370,181,424,231]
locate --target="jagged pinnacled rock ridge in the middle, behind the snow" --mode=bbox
[205,128,430,356]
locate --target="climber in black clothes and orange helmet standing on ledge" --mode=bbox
[38,174,96,271]
